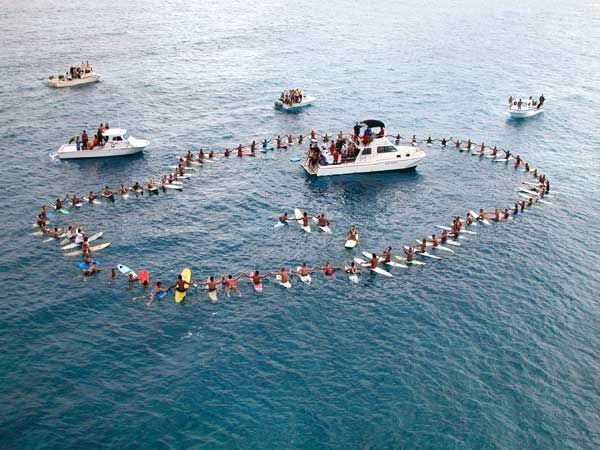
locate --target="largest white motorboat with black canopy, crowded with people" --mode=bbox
[302,120,426,177]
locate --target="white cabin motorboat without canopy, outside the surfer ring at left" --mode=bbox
[56,128,150,159]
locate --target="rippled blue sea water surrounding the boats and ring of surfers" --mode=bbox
[0,0,600,449]
